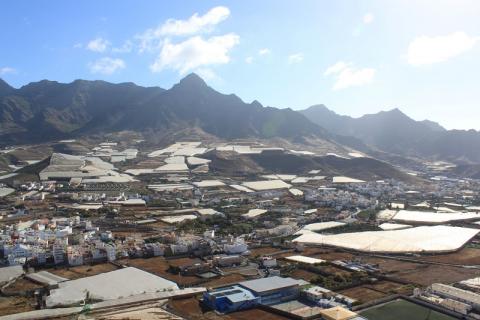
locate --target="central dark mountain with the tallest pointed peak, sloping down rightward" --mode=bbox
[120,74,328,139]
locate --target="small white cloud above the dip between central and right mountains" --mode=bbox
[324,61,376,90]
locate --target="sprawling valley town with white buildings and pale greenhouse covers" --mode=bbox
[0,137,480,320]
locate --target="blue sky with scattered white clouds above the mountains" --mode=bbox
[0,0,480,130]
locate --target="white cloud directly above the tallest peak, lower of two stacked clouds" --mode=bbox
[150,33,239,74]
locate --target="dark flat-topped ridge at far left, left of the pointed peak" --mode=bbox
[0,80,164,142]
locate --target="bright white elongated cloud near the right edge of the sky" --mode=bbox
[407,32,480,66]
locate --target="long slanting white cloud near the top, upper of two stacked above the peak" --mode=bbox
[136,6,230,52]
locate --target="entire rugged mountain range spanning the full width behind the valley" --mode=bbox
[0,74,480,164]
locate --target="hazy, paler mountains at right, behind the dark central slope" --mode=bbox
[300,105,480,163]
